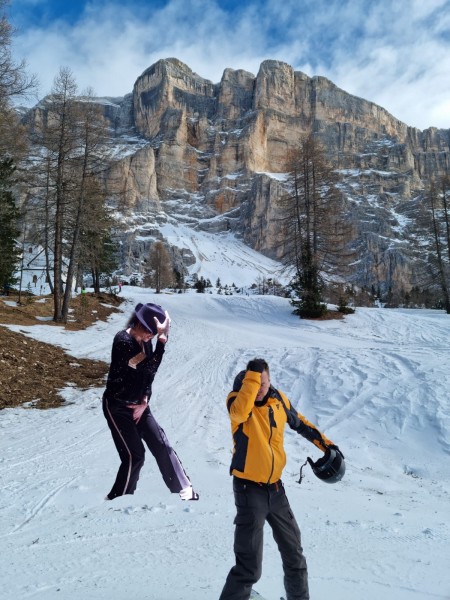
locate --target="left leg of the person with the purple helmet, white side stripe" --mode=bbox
[103,400,145,500]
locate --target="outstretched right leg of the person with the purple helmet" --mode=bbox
[138,409,191,493]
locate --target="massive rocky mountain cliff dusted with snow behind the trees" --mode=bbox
[26,58,450,290]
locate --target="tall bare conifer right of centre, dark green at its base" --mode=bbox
[281,135,351,318]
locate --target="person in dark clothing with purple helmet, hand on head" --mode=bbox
[103,304,199,500]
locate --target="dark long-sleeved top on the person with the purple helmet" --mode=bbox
[103,330,164,406]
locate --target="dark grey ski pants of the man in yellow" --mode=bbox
[219,477,309,600]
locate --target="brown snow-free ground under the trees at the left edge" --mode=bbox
[0,294,122,410]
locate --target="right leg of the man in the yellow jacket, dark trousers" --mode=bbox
[267,485,309,600]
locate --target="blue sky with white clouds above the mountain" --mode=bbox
[9,0,450,129]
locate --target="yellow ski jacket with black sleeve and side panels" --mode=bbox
[227,371,333,484]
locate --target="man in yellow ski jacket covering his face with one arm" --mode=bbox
[220,358,341,600]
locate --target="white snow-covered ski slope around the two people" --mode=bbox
[0,287,450,600]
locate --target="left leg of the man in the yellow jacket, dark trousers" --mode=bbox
[219,478,269,600]
